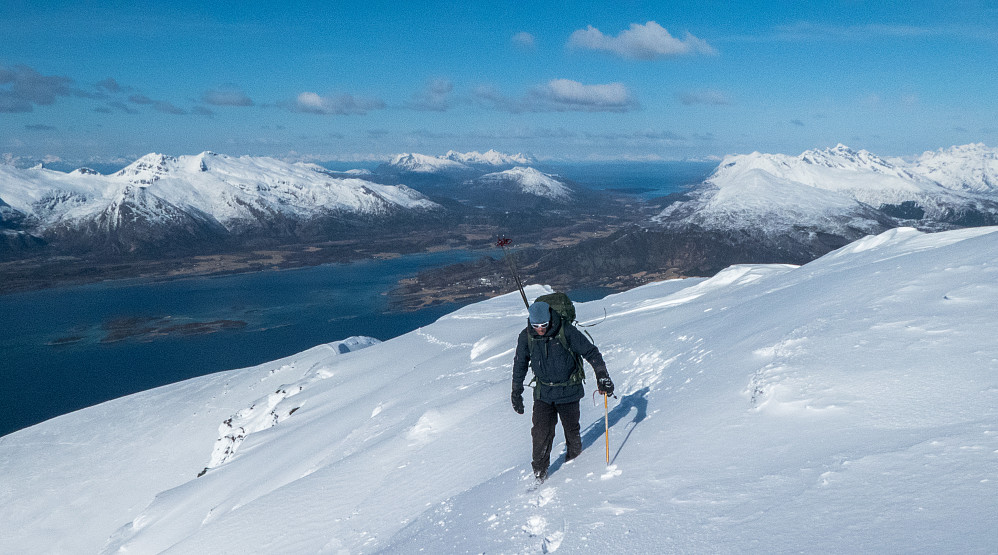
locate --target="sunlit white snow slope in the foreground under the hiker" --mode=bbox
[0,228,998,553]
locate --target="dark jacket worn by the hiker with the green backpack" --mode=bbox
[513,310,608,404]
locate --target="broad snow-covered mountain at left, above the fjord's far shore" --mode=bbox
[0,152,439,255]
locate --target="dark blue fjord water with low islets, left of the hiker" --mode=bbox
[0,251,479,436]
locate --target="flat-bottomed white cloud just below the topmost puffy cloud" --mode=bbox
[474,79,639,113]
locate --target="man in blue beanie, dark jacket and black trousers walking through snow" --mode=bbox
[511,301,613,482]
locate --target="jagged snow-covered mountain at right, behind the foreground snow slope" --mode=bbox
[654,144,998,239]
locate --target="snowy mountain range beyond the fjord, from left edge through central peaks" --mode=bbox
[0,150,577,258]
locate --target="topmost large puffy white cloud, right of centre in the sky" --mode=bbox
[568,21,717,60]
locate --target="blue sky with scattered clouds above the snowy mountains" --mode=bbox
[0,0,998,162]
